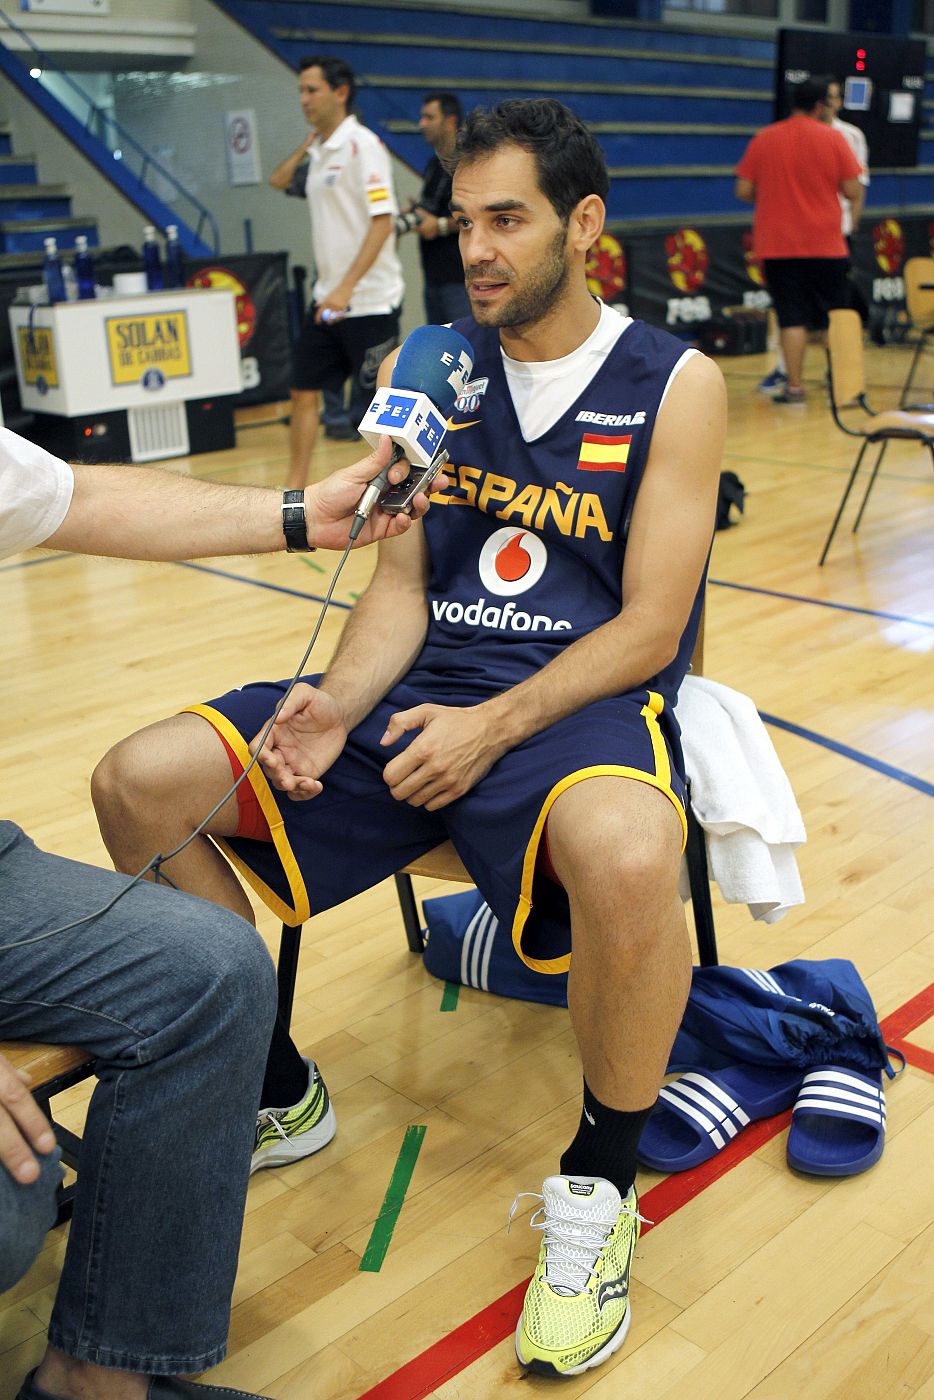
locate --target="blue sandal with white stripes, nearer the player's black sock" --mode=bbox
[639,1064,801,1172]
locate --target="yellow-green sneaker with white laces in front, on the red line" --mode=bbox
[510,1176,641,1376]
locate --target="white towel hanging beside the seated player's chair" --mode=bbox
[678,676,807,924]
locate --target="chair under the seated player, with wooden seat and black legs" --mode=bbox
[277,610,717,1025]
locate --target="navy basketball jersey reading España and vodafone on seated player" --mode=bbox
[407,318,703,704]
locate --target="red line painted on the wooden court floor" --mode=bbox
[358,983,934,1400]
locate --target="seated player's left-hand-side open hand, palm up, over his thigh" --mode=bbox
[249,680,347,802]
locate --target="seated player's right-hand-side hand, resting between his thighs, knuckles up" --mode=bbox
[379,704,508,812]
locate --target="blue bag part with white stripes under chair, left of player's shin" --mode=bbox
[421,889,567,1007]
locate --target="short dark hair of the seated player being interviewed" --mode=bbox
[452,97,609,224]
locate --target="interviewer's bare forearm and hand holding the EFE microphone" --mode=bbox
[43,438,442,560]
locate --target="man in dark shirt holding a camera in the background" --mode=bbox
[396,92,471,325]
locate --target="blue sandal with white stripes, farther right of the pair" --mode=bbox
[788,1064,885,1176]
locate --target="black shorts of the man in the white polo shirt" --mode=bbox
[291,304,399,414]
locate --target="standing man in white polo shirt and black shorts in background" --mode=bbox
[269,57,405,490]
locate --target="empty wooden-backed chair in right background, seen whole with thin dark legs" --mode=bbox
[818,309,934,567]
